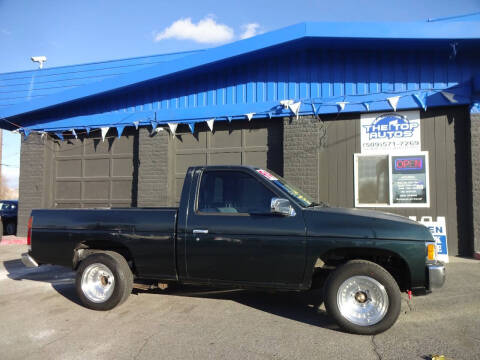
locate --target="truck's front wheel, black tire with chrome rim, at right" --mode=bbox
[325,260,401,335]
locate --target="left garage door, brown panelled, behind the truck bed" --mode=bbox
[52,136,134,208]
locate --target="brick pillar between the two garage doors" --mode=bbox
[137,128,169,207]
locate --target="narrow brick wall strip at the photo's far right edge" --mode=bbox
[470,113,480,252]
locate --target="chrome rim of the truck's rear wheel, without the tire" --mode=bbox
[81,263,115,303]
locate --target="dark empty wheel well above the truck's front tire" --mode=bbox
[317,248,411,291]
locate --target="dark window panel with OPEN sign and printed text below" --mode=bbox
[391,153,428,205]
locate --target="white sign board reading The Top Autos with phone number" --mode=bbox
[360,110,421,154]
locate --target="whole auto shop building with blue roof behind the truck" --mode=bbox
[0,22,480,256]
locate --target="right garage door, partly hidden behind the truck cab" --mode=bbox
[169,119,283,205]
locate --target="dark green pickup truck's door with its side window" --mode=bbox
[185,168,306,286]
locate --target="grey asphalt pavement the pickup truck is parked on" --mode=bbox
[0,245,480,360]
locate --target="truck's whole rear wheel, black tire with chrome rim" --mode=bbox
[75,251,133,310]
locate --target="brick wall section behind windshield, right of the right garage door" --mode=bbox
[283,117,322,200]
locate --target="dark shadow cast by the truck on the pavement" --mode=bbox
[3,259,339,330]
